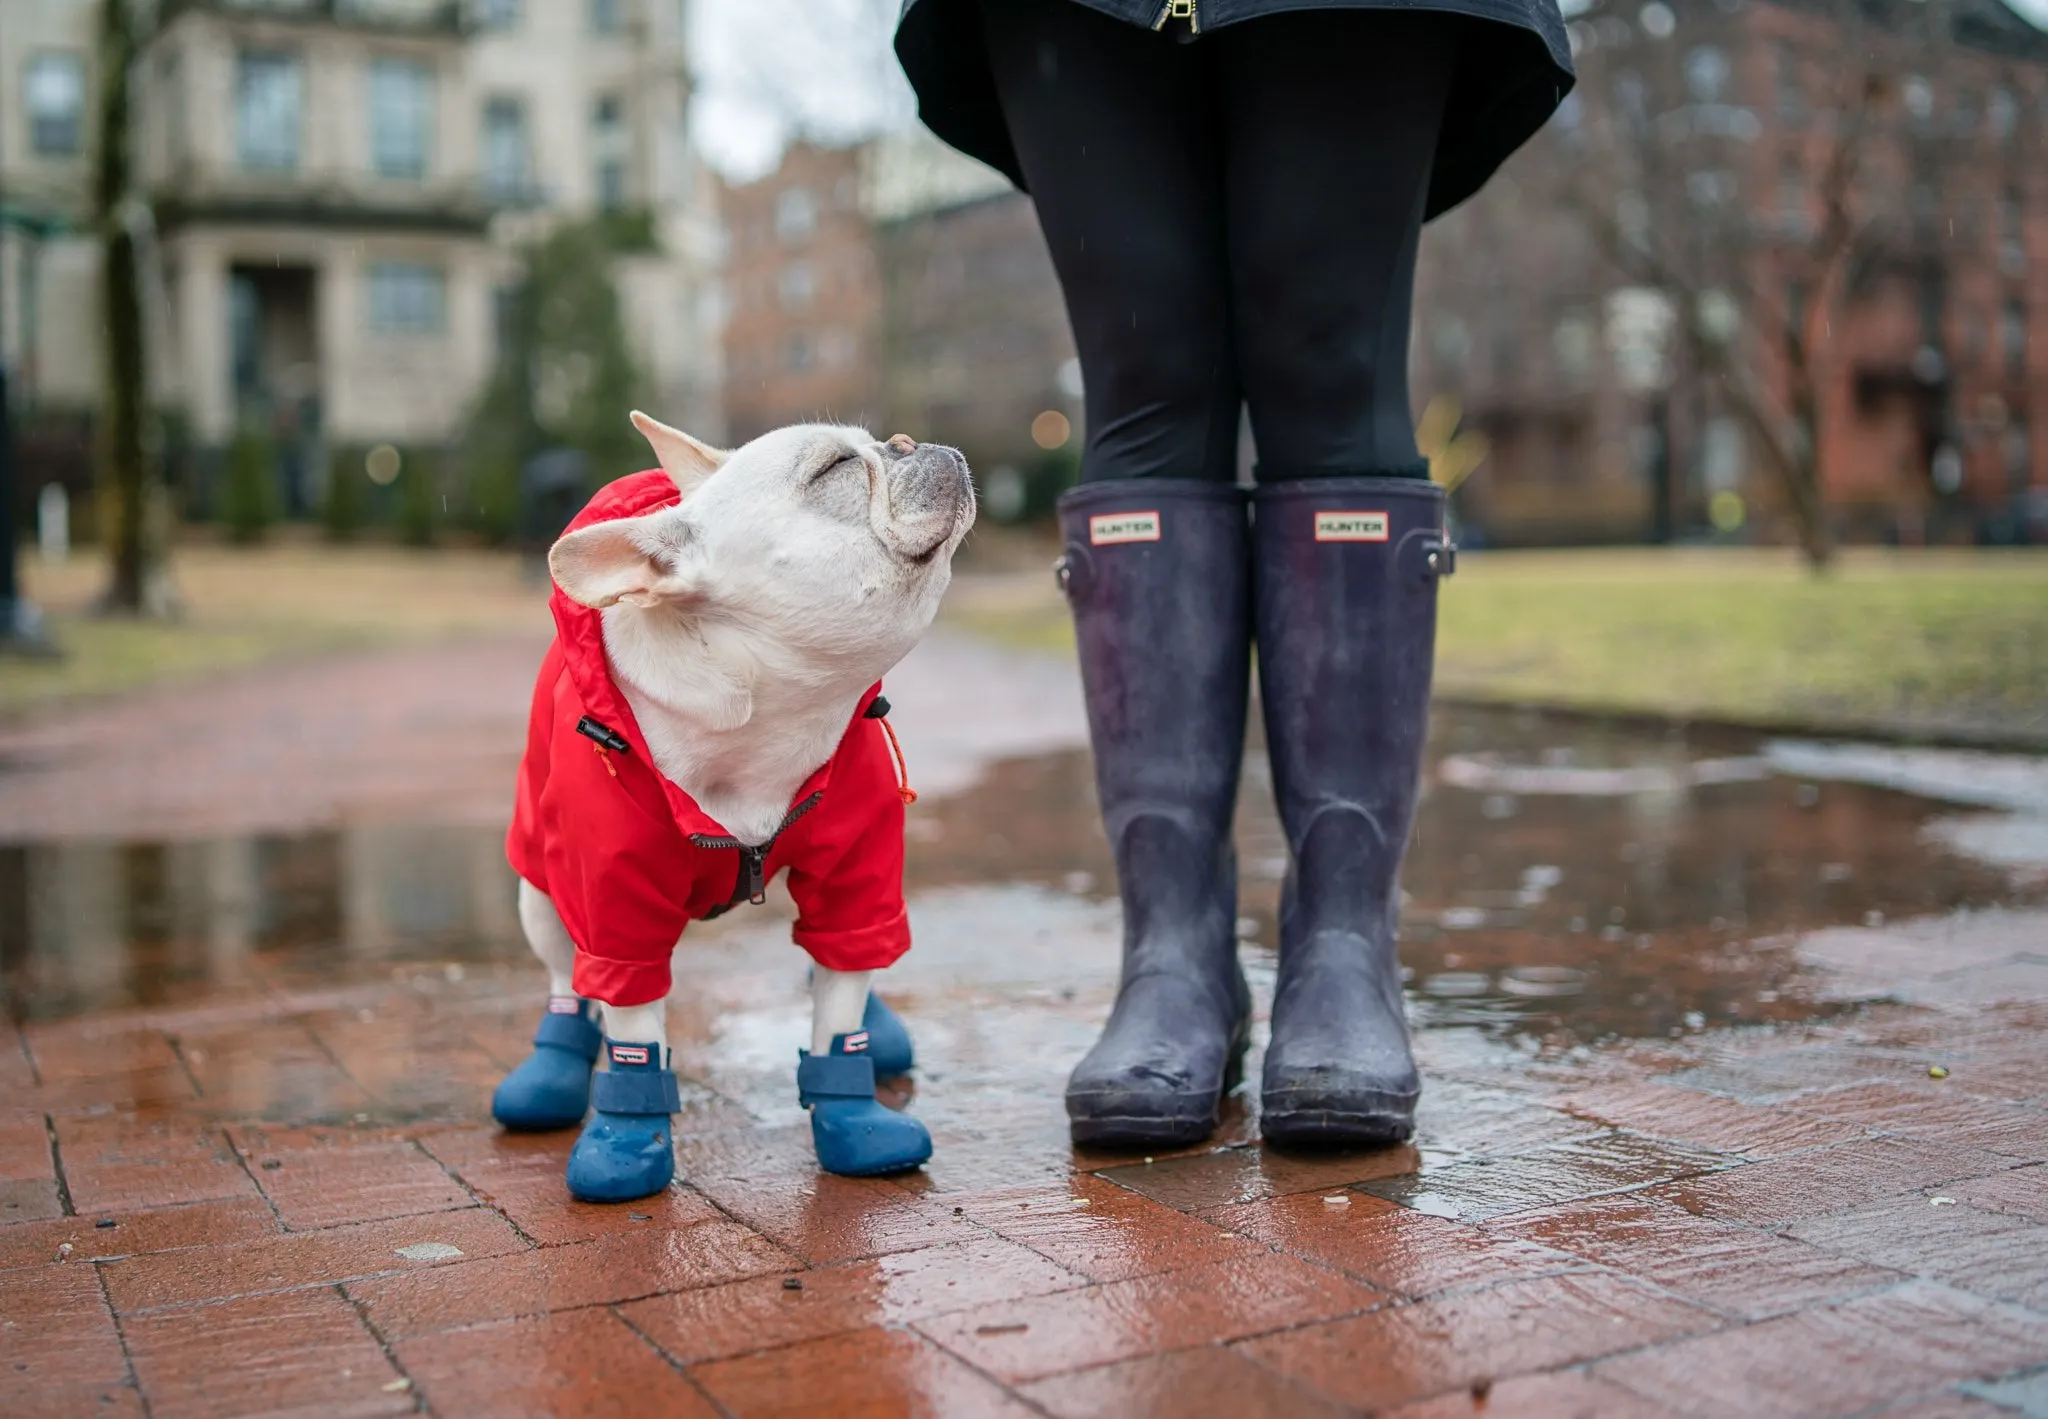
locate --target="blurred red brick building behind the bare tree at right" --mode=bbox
[1413,0,2048,543]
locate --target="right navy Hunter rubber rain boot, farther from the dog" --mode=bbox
[1251,477,1454,1147]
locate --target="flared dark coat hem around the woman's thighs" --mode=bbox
[895,0,1573,217]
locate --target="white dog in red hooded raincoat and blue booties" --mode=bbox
[494,414,975,1200]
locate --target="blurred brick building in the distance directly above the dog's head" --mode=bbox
[723,131,1081,516]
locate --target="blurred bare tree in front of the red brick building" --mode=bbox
[1554,0,2048,569]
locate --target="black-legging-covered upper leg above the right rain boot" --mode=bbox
[1206,10,1464,483]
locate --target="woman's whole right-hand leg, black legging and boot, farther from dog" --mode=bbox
[1219,12,1460,1145]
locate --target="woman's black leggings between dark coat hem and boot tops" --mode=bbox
[981,0,1462,481]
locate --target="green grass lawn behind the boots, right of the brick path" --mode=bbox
[948,549,2048,745]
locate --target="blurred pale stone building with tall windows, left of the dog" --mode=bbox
[0,0,719,503]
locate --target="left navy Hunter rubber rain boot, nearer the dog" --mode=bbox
[1059,479,1251,1147]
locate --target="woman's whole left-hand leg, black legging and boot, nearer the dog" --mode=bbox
[983,0,1249,1147]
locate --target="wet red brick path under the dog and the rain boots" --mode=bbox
[0,647,2048,1419]
